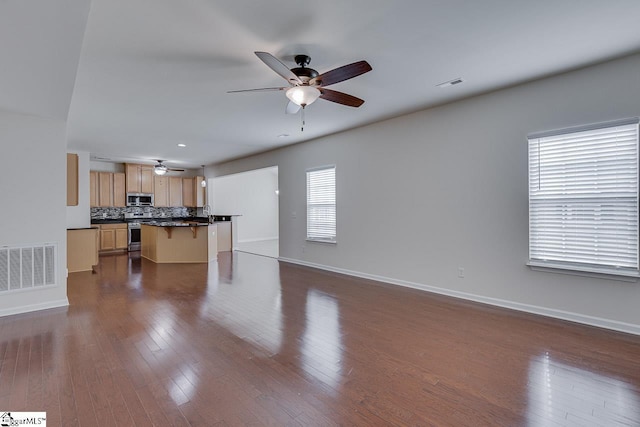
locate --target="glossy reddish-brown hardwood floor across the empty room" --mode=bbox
[0,253,640,427]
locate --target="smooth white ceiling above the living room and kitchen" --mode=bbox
[0,0,640,167]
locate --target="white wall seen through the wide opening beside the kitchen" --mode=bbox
[209,167,278,243]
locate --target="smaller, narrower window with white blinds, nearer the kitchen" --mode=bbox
[307,166,336,243]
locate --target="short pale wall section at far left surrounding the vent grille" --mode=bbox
[0,111,68,316]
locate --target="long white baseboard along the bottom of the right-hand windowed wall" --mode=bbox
[278,257,640,335]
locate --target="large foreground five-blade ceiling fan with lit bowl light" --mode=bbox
[227,52,372,129]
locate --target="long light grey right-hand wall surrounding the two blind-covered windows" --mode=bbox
[209,55,640,333]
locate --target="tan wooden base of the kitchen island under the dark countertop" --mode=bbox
[140,224,218,264]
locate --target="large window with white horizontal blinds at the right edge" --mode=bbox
[528,119,638,276]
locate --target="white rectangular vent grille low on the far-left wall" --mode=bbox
[0,243,57,293]
